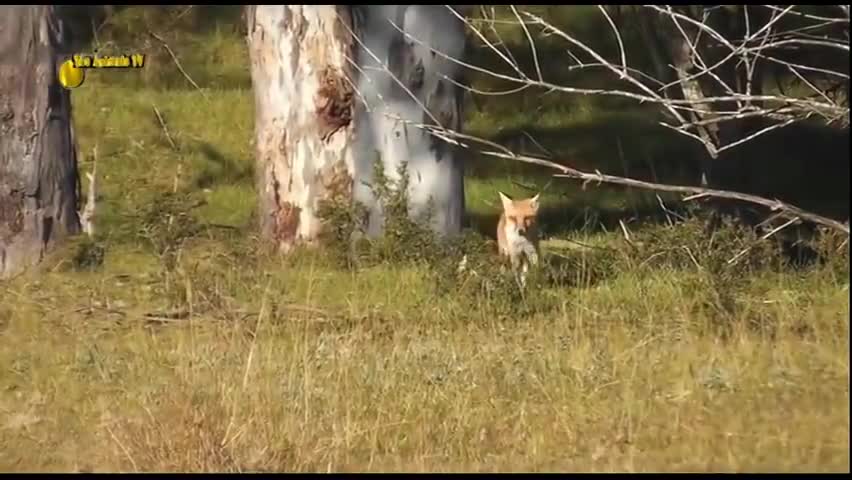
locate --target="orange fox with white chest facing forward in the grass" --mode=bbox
[497,192,540,286]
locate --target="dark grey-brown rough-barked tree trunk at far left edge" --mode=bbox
[0,5,80,278]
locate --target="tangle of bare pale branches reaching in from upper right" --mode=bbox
[342,5,849,235]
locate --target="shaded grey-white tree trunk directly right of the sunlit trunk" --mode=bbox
[354,5,465,235]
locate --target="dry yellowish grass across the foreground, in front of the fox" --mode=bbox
[0,226,849,472]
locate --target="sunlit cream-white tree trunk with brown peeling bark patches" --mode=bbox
[247,5,353,251]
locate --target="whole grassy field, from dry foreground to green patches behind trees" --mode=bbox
[0,6,850,472]
